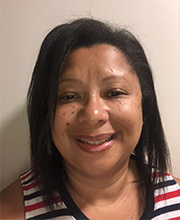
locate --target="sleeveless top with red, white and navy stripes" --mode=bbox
[20,170,180,220]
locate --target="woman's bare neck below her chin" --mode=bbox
[66,158,138,207]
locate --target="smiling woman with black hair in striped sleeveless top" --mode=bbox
[1,19,180,220]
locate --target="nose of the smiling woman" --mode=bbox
[77,96,109,126]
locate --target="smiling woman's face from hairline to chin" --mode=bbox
[52,44,142,179]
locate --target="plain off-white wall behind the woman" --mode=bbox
[0,0,180,190]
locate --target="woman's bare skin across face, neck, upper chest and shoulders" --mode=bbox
[0,45,180,220]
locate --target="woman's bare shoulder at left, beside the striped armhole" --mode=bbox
[0,179,25,220]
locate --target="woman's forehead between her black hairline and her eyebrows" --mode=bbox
[62,44,132,77]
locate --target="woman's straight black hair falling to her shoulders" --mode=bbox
[27,18,168,206]
